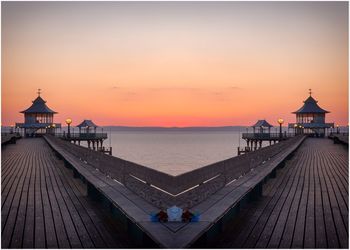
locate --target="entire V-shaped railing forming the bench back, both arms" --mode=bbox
[46,136,302,207]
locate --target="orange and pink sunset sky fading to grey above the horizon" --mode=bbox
[1,2,348,126]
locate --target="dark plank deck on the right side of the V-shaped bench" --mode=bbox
[206,138,349,248]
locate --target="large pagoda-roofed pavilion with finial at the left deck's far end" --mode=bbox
[16,89,61,137]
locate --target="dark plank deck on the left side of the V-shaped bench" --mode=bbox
[1,138,133,248]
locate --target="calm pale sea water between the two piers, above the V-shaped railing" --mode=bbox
[87,131,268,175]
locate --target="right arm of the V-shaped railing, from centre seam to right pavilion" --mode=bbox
[176,136,302,206]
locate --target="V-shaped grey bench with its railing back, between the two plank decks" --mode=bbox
[38,136,304,248]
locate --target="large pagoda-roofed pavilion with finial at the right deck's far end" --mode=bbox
[288,89,334,137]
